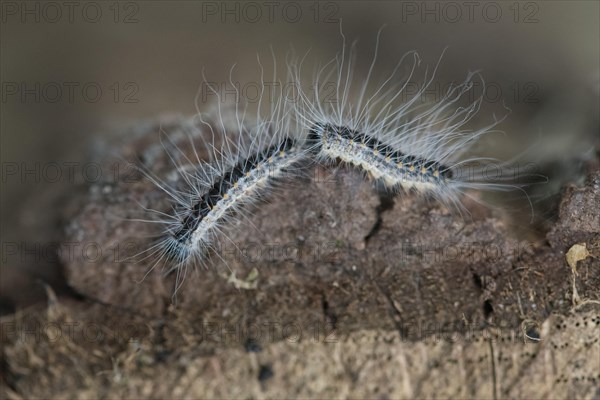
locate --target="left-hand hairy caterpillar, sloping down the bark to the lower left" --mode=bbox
[134,75,310,293]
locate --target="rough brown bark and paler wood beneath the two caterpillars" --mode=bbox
[2,116,600,398]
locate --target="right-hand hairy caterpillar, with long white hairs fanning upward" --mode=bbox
[291,28,531,212]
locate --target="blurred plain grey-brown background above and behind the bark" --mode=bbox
[0,1,600,312]
